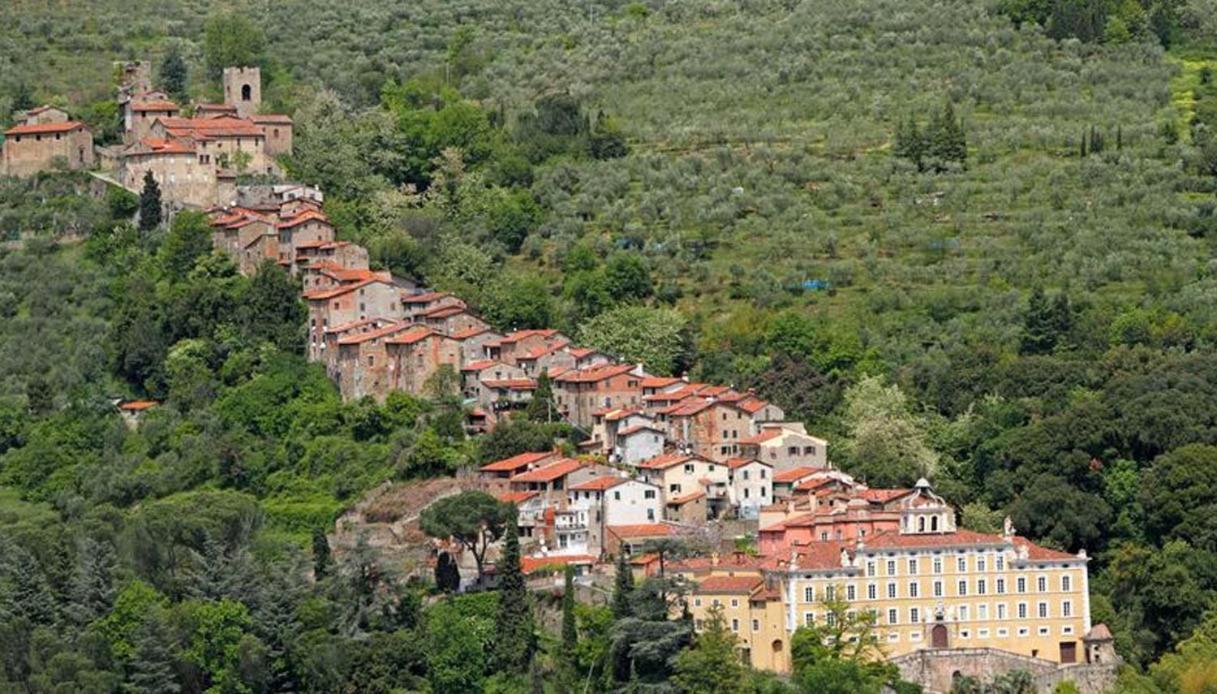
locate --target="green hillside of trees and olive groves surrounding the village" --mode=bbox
[0,0,1217,692]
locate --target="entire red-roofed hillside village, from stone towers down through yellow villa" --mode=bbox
[2,63,1118,692]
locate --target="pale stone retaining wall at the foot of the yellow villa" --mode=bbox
[891,648,1118,694]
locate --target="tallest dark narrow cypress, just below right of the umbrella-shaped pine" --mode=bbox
[494,509,533,675]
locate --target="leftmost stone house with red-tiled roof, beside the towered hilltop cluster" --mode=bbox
[0,121,94,177]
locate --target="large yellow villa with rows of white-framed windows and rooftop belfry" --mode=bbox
[689,480,1092,672]
